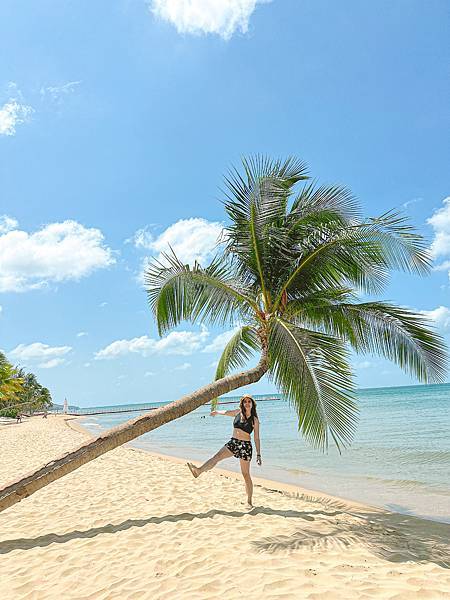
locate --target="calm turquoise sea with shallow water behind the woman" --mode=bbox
[78,384,450,523]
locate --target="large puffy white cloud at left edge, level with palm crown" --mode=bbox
[0,221,115,292]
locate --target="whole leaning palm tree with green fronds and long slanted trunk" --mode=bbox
[0,157,447,510]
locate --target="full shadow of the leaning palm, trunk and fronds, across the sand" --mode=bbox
[0,492,450,568]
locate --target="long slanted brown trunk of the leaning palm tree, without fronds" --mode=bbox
[0,354,267,511]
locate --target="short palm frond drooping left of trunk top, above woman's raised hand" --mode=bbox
[211,325,261,410]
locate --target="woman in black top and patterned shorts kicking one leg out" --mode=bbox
[187,395,262,508]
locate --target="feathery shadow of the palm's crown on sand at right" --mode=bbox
[252,494,450,569]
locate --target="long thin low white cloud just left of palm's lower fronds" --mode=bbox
[95,327,209,360]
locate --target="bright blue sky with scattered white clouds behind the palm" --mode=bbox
[0,0,450,406]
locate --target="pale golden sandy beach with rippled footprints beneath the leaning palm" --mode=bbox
[0,416,450,600]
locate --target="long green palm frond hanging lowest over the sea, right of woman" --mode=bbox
[268,318,357,449]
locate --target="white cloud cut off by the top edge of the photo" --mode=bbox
[150,0,268,40]
